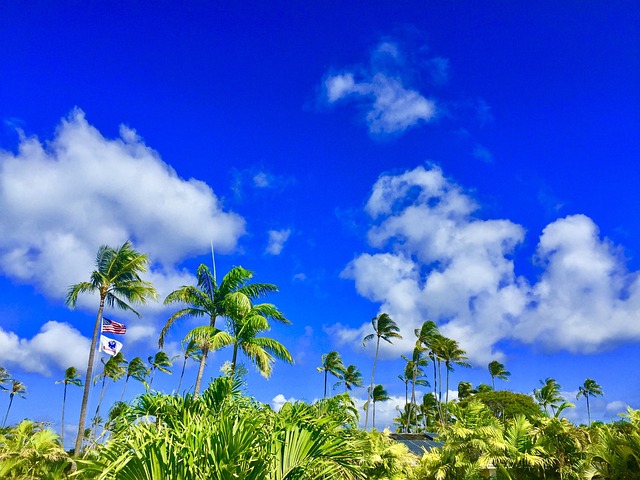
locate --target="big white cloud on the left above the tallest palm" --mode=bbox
[0,109,245,304]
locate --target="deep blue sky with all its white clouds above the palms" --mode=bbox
[0,2,640,438]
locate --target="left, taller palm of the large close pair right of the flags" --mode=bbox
[158,264,278,396]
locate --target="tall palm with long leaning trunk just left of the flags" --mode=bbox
[66,240,158,454]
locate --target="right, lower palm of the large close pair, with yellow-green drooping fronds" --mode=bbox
[225,292,293,378]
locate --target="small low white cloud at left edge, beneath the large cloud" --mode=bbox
[0,320,91,376]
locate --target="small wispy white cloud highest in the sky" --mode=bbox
[323,41,438,134]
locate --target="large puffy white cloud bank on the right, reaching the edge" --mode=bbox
[336,167,640,364]
